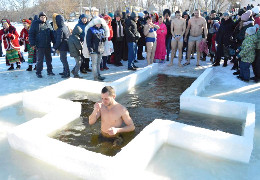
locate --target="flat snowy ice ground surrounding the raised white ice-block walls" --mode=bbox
[0,25,260,180]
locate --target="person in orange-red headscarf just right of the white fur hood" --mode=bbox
[100,15,113,71]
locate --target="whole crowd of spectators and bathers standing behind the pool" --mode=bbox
[0,6,260,82]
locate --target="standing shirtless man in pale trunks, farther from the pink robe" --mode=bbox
[183,9,208,66]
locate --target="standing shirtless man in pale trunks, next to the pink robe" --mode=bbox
[168,11,186,67]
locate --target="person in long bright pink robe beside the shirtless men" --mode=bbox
[154,16,167,63]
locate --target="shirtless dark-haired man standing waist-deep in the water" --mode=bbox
[89,86,135,138]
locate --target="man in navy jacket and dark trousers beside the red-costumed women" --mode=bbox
[29,12,55,78]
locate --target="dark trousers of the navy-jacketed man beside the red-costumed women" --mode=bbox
[36,48,52,74]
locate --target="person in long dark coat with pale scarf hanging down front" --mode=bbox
[111,11,125,66]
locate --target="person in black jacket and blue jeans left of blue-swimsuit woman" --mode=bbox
[125,12,141,71]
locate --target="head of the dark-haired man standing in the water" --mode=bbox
[101,86,116,106]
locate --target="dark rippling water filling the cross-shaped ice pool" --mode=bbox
[54,74,243,156]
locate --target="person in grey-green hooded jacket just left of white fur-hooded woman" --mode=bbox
[68,26,82,78]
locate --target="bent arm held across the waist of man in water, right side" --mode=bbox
[108,108,135,135]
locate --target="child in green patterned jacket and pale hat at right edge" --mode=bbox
[237,27,257,82]
